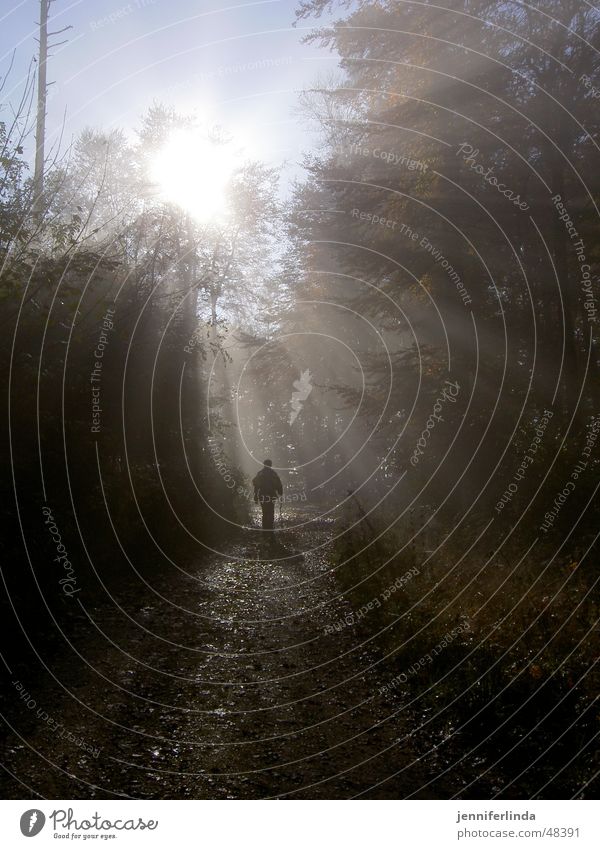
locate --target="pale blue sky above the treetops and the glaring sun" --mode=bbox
[0,0,337,179]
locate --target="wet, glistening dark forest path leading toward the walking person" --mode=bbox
[2,509,434,798]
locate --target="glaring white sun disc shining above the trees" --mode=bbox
[150,130,241,221]
